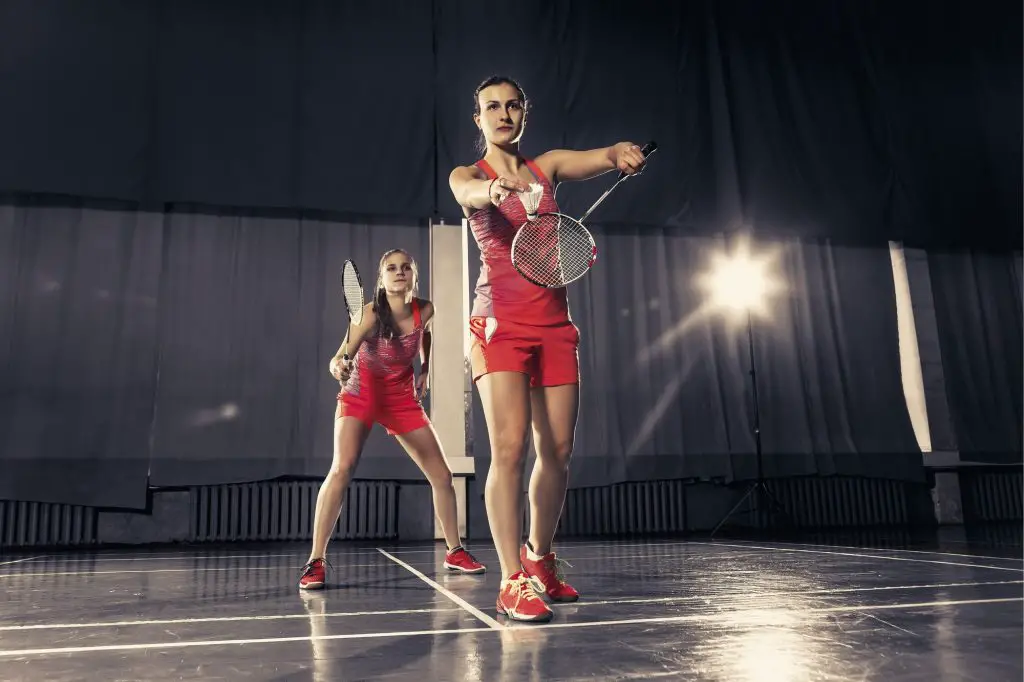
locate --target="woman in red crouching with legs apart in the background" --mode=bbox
[299,249,485,590]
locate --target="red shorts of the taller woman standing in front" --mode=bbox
[469,316,580,388]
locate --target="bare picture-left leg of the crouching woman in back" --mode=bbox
[309,417,371,561]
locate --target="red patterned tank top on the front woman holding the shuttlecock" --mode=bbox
[469,159,569,327]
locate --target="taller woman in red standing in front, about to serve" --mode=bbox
[449,76,644,621]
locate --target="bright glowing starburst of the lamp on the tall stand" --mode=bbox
[697,235,781,314]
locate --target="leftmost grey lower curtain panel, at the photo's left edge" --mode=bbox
[0,193,163,508]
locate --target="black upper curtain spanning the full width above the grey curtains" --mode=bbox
[0,0,1024,248]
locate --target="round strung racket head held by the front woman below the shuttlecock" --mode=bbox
[512,213,597,289]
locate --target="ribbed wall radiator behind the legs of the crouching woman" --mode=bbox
[189,481,398,542]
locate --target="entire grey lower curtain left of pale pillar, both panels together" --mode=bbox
[0,197,430,508]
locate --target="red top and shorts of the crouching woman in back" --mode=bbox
[335,298,430,435]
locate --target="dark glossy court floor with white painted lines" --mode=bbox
[0,528,1024,682]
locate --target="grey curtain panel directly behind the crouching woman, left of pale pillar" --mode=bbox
[151,209,429,485]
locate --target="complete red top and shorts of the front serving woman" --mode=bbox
[469,159,580,386]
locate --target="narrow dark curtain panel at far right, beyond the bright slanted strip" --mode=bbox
[928,251,1024,463]
